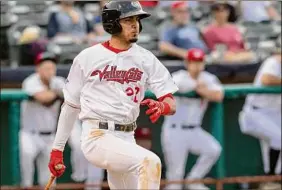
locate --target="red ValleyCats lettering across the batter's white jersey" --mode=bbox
[91,65,143,84]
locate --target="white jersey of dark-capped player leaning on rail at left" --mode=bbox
[21,74,65,132]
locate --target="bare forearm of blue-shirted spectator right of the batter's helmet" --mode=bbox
[159,42,187,59]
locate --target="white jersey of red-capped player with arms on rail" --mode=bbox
[166,70,222,126]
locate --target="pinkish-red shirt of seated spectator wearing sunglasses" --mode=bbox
[203,24,245,52]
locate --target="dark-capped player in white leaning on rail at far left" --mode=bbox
[19,52,65,188]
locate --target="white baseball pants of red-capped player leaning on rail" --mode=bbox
[161,122,221,189]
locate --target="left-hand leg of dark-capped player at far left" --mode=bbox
[19,131,39,187]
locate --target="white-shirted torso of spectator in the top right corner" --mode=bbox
[239,1,281,22]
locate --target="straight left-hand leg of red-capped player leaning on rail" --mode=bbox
[161,122,189,189]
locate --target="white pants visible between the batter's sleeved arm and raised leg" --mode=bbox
[69,119,104,190]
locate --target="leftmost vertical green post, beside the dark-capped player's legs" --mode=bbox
[8,101,20,185]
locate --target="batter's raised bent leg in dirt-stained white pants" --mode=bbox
[83,135,161,189]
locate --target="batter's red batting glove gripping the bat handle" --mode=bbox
[48,150,66,177]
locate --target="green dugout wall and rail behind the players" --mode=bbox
[0,85,281,189]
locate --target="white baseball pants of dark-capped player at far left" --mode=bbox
[19,130,55,187]
